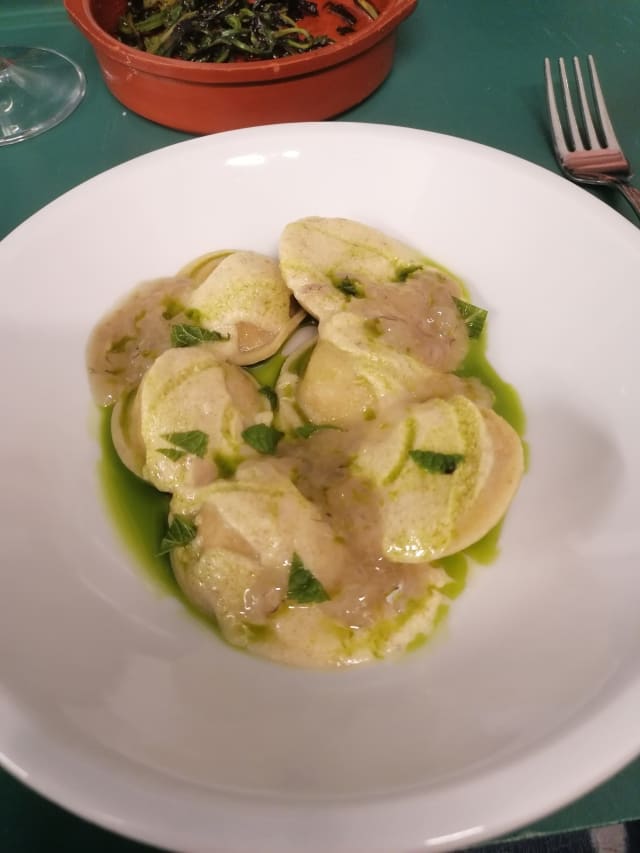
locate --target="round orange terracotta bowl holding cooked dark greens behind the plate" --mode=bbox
[65,0,417,133]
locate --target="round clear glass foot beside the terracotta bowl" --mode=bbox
[0,45,86,146]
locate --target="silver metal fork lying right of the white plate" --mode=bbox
[544,55,640,221]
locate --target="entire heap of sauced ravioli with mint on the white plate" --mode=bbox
[88,217,524,667]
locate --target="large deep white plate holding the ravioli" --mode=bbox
[0,123,640,853]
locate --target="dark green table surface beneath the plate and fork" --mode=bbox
[0,0,640,853]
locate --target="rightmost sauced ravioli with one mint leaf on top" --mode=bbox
[351,396,524,563]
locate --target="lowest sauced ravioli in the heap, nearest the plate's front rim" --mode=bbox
[171,460,447,666]
